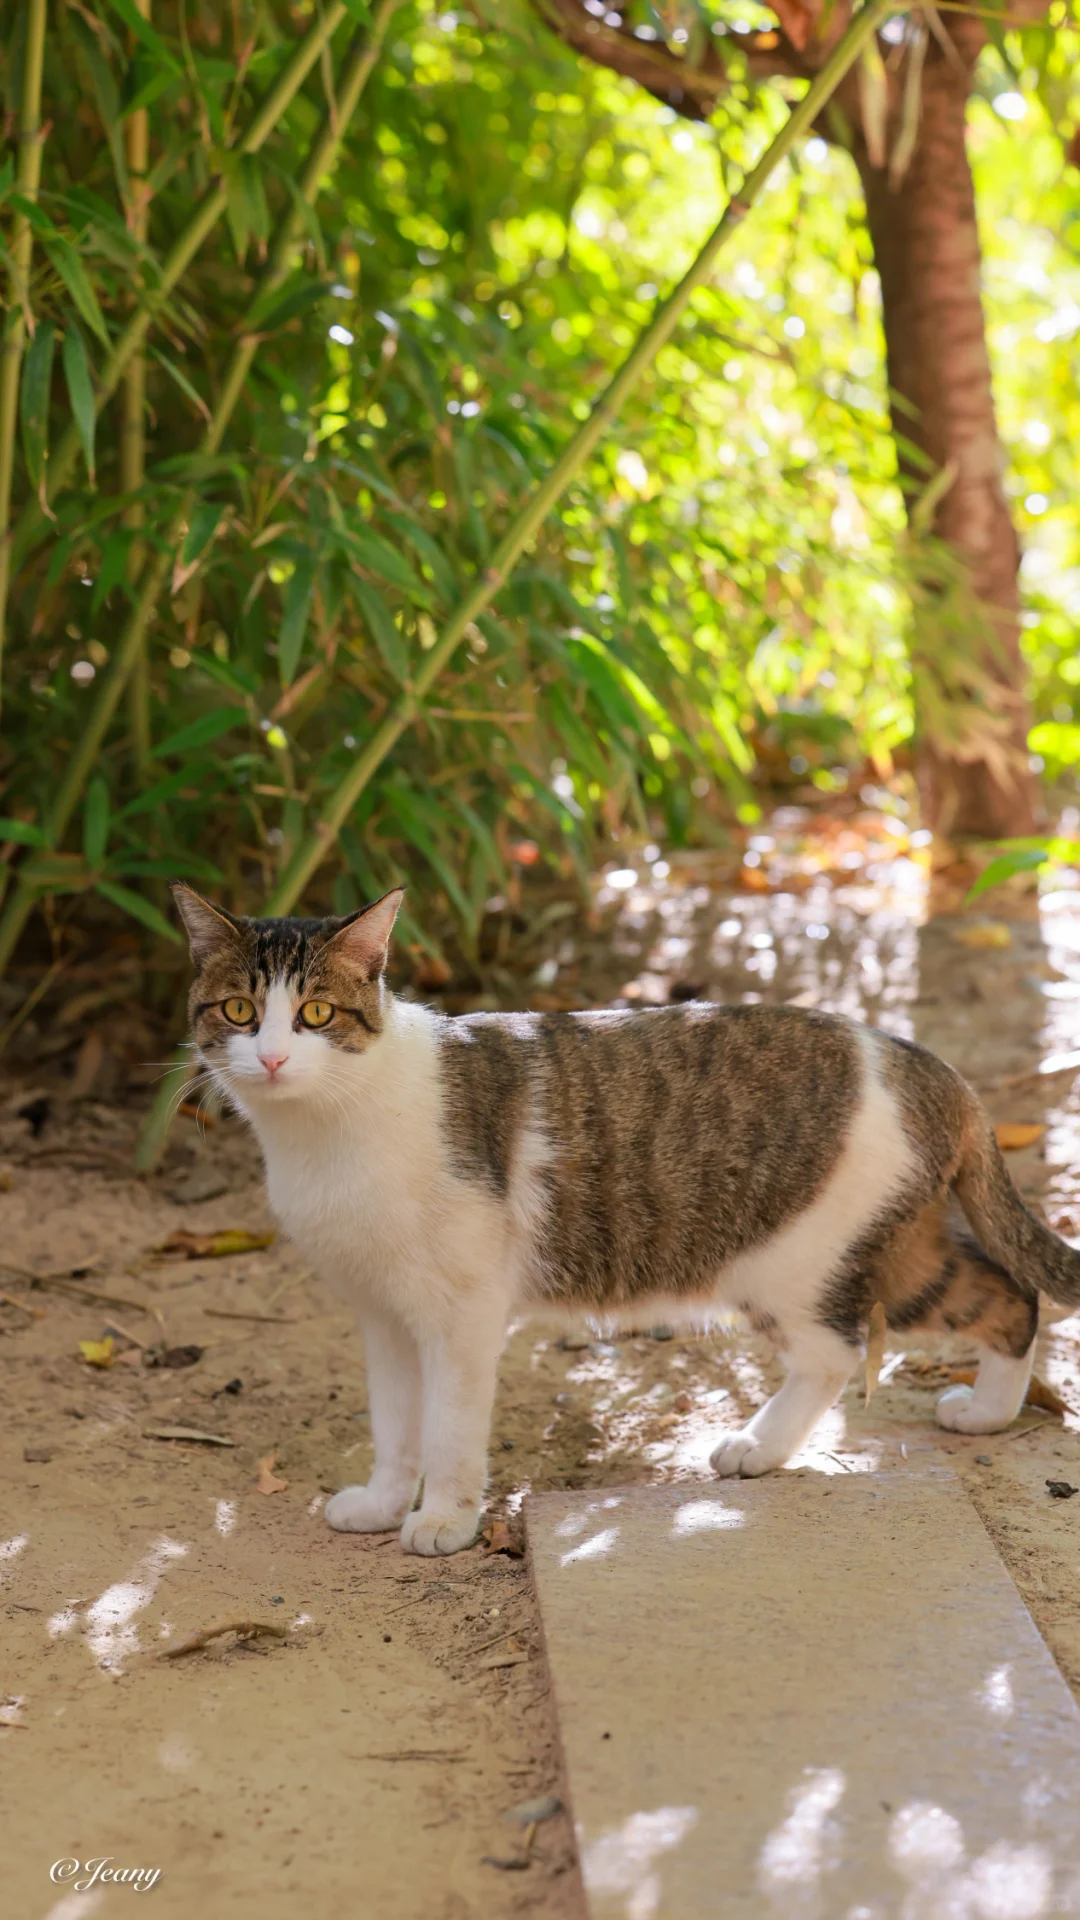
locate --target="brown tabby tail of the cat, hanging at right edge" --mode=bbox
[953,1096,1080,1306]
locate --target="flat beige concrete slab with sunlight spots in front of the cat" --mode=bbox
[527,1467,1080,1920]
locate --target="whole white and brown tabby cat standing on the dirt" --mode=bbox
[173,883,1080,1553]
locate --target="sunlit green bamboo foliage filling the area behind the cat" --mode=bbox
[0,0,1080,960]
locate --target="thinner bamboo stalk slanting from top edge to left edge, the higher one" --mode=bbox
[10,0,348,572]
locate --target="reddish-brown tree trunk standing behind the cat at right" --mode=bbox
[855,35,1036,837]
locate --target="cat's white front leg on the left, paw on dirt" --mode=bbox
[327,1308,421,1534]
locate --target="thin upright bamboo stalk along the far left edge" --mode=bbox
[0,0,48,721]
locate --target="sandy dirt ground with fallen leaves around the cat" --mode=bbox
[0,810,1080,1920]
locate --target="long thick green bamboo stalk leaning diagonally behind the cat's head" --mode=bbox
[125,0,901,1173]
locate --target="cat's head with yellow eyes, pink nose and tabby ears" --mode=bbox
[173,881,404,1110]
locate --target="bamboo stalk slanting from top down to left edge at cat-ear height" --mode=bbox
[0,0,402,973]
